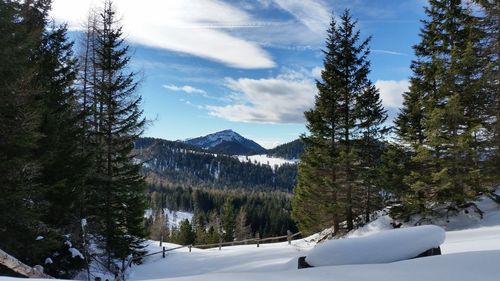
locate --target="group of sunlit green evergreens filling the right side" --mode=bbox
[292,0,500,234]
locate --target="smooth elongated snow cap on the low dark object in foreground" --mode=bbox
[306,225,446,266]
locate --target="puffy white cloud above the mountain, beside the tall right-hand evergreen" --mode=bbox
[207,71,316,124]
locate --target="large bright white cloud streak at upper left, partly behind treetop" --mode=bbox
[51,0,276,69]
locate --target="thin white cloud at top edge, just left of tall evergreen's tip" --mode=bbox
[274,0,331,34]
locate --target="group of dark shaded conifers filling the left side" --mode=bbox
[0,0,146,278]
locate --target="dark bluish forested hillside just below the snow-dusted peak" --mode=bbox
[134,138,297,192]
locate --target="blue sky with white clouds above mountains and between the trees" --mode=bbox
[51,0,426,148]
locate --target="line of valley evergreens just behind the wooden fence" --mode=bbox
[148,185,297,245]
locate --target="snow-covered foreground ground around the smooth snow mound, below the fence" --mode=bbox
[0,194,500,281]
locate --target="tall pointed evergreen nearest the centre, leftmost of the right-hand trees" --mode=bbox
[292,10,386,234]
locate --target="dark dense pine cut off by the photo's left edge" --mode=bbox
[0,1,50,265]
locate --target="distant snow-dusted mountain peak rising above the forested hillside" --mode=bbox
[184,130,266,155]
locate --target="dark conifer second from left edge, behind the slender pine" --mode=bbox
[37,21,88,237]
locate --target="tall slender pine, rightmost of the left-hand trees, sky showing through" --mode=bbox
[88,1,146,268]
